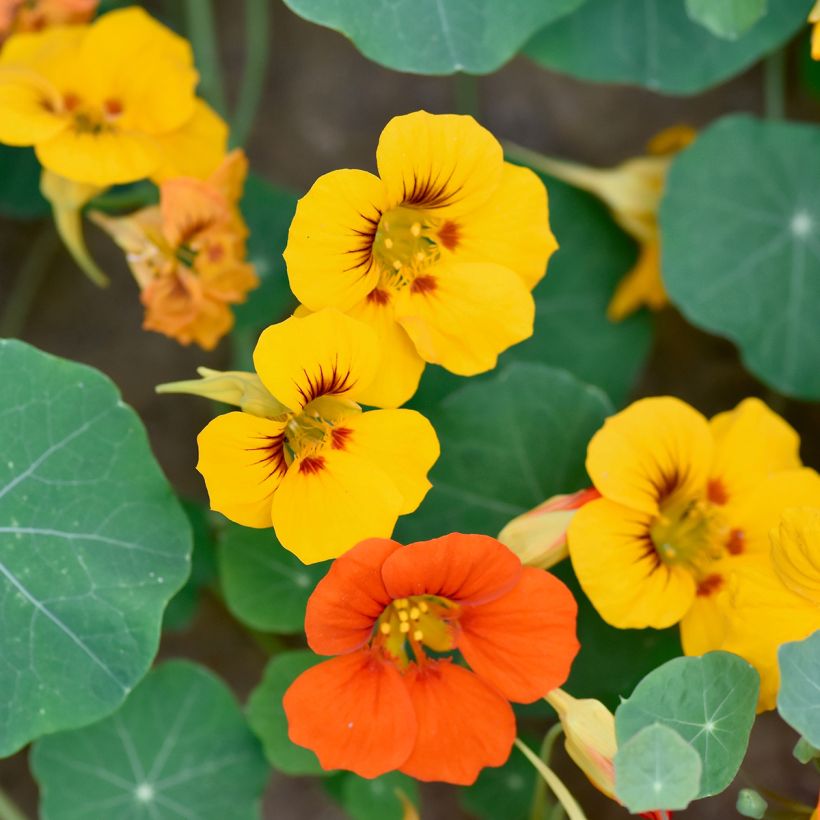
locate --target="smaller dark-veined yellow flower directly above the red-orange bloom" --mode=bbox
[191,309,439,564]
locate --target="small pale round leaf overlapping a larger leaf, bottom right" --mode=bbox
[614,723,702,814]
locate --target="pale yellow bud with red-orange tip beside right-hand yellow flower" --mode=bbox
[498,487,600,569]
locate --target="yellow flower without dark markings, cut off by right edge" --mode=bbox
[721,507,820,709]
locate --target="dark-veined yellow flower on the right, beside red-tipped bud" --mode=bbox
[568,397,820,655]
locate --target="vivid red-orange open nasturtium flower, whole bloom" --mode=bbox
[284,533,578,785]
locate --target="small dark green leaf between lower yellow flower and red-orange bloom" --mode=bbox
[218,524,328,633]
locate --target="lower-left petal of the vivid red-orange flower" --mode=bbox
[282,651,416,777]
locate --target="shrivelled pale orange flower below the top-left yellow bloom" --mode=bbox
[91,150,259,350]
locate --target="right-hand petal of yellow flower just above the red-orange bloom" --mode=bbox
[342,410,440,515]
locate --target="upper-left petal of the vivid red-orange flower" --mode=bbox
[305,538,402,655]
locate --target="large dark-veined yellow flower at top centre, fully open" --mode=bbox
[285,111,557,406]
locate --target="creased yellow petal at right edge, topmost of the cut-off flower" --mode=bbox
[771,507,820,606]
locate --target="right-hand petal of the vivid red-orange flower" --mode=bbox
[457,567,580,703]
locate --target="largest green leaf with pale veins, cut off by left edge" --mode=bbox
[0,340,191,756]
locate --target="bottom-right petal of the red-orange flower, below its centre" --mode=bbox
[401,661,515,786]
